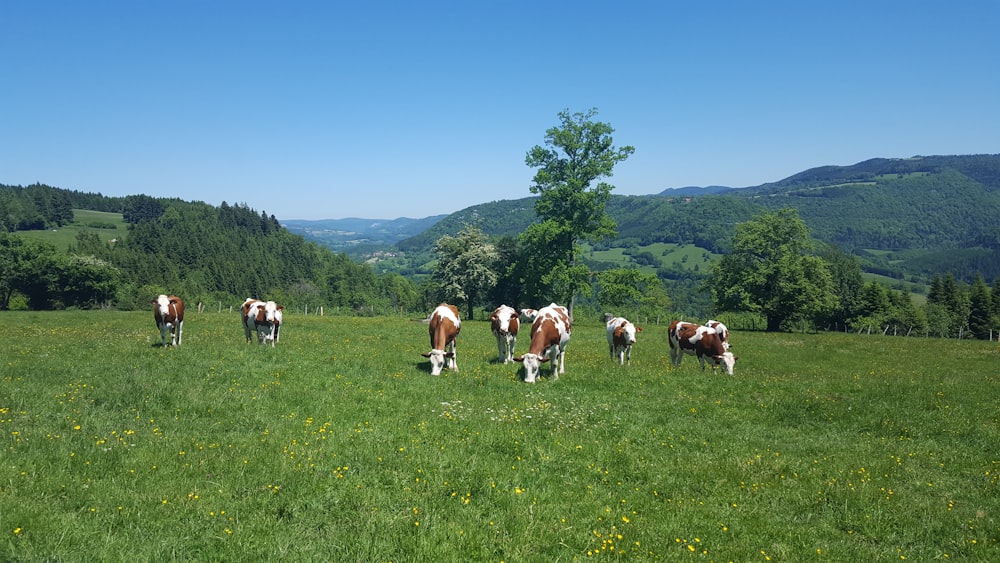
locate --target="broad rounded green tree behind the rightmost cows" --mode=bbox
[709,208,836,331]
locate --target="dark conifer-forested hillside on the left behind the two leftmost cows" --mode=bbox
[0,186,426,313]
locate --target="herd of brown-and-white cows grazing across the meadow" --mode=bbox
[152,295,737,383]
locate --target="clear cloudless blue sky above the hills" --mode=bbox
[0,0,1000,219]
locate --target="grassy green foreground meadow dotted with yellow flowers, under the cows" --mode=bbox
[0,312,1000,562]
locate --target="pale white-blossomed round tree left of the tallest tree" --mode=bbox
[434,225,498,319]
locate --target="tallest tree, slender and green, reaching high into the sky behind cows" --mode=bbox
[522,109,635,308]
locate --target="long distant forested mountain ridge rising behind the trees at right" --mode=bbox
[388,155,1000,282]
